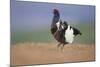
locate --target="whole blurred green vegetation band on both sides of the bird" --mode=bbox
[11,24,95,44]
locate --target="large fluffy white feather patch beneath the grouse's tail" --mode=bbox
[65,25,74,43]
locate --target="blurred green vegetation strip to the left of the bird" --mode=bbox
[11,30,53,43]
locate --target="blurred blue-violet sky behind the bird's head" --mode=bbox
[11,0,95,31]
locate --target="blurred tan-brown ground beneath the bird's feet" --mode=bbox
[11,43,95,65]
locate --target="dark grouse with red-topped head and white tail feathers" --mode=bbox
[51,9,81,47]
